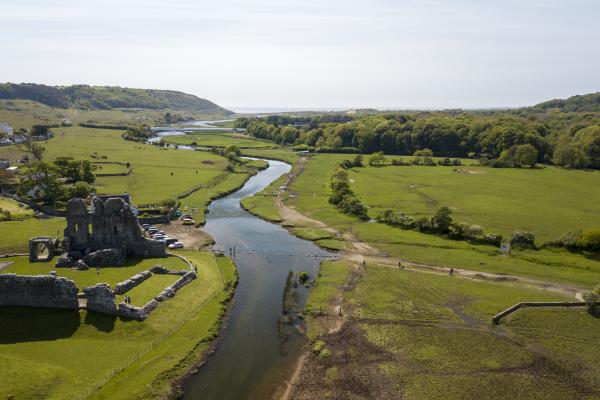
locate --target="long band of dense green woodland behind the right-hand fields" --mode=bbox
[235,110,600,168]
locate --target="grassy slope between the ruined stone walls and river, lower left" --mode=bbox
[0,252,236,399]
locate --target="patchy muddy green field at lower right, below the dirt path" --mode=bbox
[293,262,600,399]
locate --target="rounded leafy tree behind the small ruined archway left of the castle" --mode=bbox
[19,161,65,205]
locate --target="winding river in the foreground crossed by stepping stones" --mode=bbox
[183,161,333,400]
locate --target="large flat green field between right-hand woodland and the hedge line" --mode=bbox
[349,159,600,242]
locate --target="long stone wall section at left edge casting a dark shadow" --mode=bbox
[0,274,79,310]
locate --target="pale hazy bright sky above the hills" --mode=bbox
[0,0,600,110]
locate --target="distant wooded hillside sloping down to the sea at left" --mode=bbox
[0,83,231,114]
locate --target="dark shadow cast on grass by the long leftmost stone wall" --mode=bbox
[0,307,81,344]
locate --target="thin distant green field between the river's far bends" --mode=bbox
[163,132,278,149]
